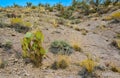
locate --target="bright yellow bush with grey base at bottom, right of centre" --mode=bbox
[79,54,100,78]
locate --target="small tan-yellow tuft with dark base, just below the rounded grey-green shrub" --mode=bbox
[51,55,70,69]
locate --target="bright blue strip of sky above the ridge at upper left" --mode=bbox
[0,0,72,7]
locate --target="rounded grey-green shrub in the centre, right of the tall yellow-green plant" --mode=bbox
[50,41,73,55]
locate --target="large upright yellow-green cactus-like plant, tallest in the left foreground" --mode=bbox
[21,30,46,66]
